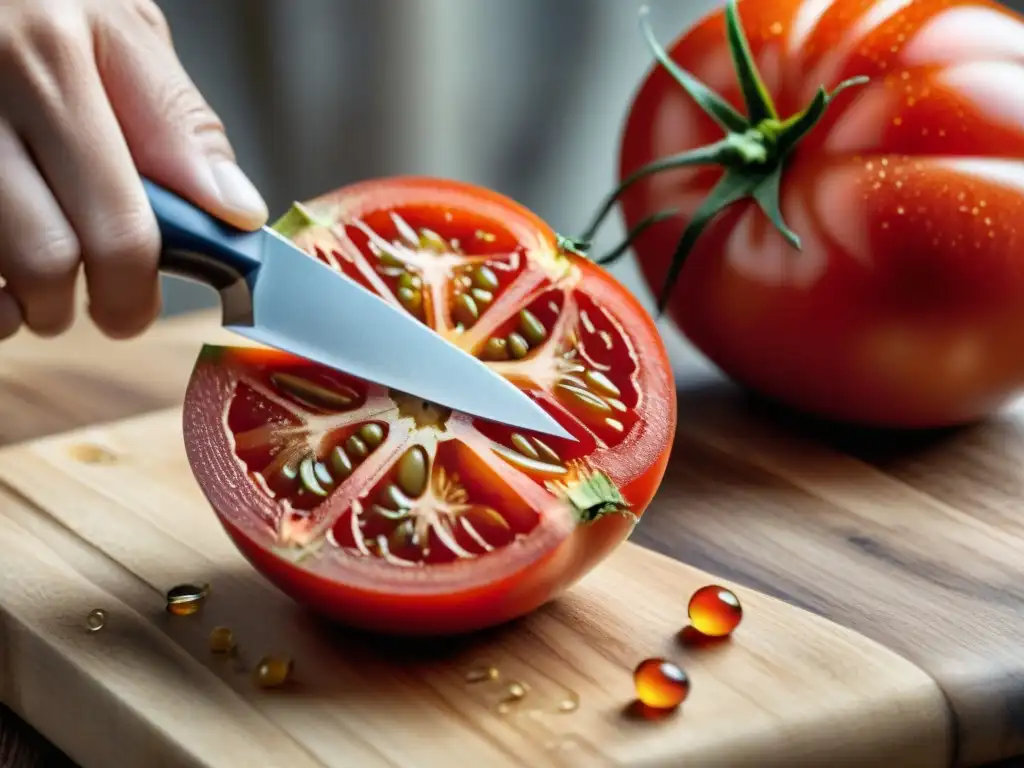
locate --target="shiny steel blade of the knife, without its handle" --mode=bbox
[225,227,575,440]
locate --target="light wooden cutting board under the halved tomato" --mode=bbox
[0,410,951,768]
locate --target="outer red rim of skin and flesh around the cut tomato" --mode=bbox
[183,178,676,635]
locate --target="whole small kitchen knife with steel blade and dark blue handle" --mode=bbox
[142,178,575,440]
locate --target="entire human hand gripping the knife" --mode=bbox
[0,0,267,339]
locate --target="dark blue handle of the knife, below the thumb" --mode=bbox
[142,178,263,294]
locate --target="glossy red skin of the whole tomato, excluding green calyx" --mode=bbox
[620,0,1024,428]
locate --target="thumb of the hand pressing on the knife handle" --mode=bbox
[96,12,267,229]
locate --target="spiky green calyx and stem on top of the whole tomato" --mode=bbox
[577,0,868,313]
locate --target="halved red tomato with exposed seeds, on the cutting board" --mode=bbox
[184,178,676,634]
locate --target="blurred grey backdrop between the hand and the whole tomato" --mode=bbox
[160,0,716,366]
